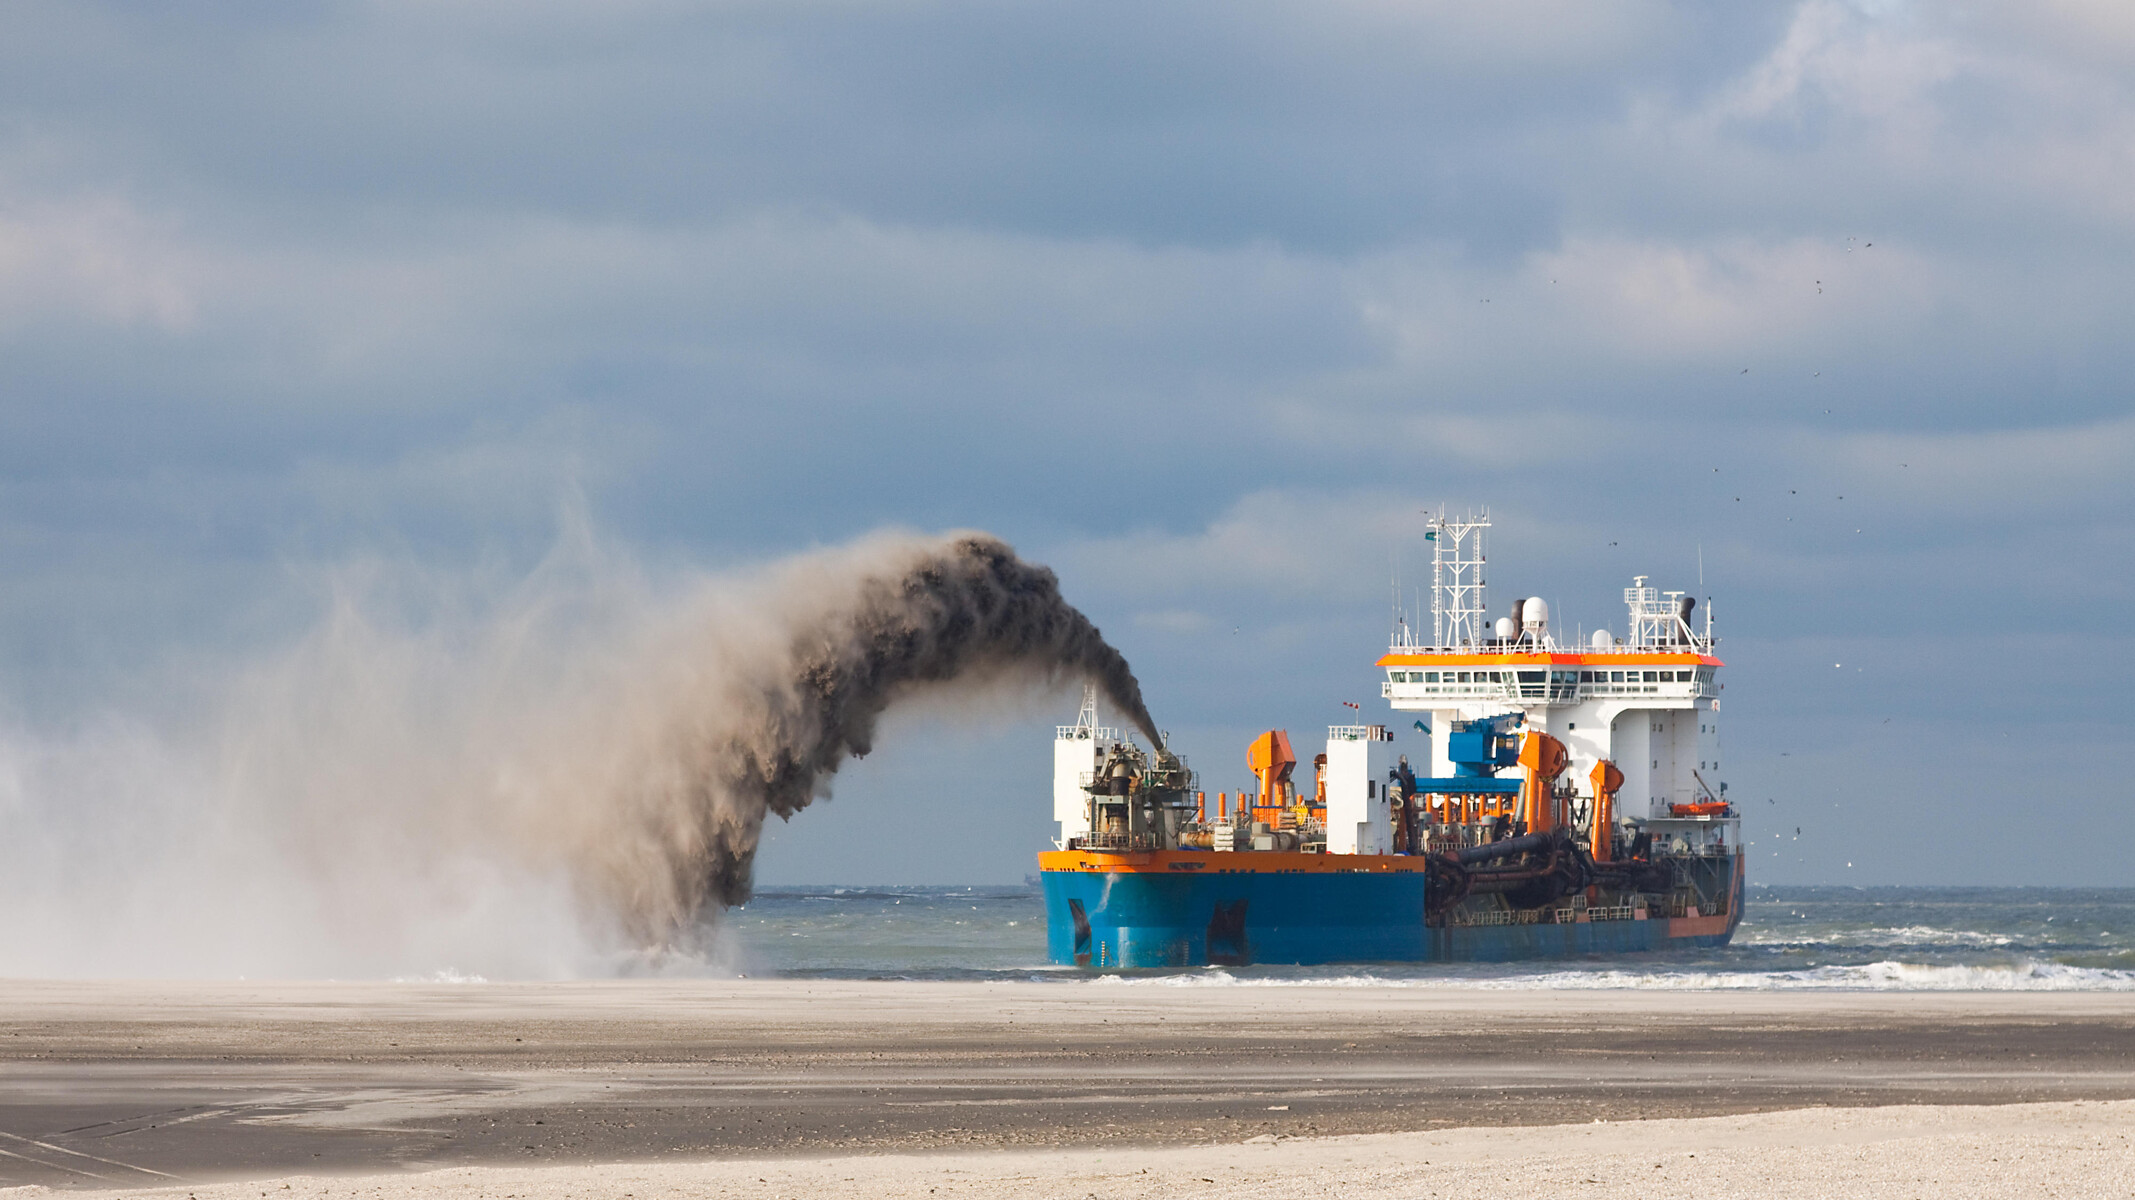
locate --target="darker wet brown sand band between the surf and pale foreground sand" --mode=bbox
[0,980,2135,1196]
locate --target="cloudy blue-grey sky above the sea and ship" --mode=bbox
[0,0,2135,884]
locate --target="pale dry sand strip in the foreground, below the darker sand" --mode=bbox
[6,1102,2135,1200]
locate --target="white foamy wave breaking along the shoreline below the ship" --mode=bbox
[1091,961,2135,991]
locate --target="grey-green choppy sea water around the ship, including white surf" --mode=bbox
[724,886,2135,991]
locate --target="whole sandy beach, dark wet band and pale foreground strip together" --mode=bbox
[0,980,2135,1198]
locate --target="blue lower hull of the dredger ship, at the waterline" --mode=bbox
[1040,860,1742,969]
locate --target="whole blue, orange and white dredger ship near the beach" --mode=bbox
[1038,512,1744,969]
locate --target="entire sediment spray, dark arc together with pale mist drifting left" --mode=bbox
[0,534,1153,978]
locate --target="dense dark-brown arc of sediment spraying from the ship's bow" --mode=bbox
[567,534,1159,944]
